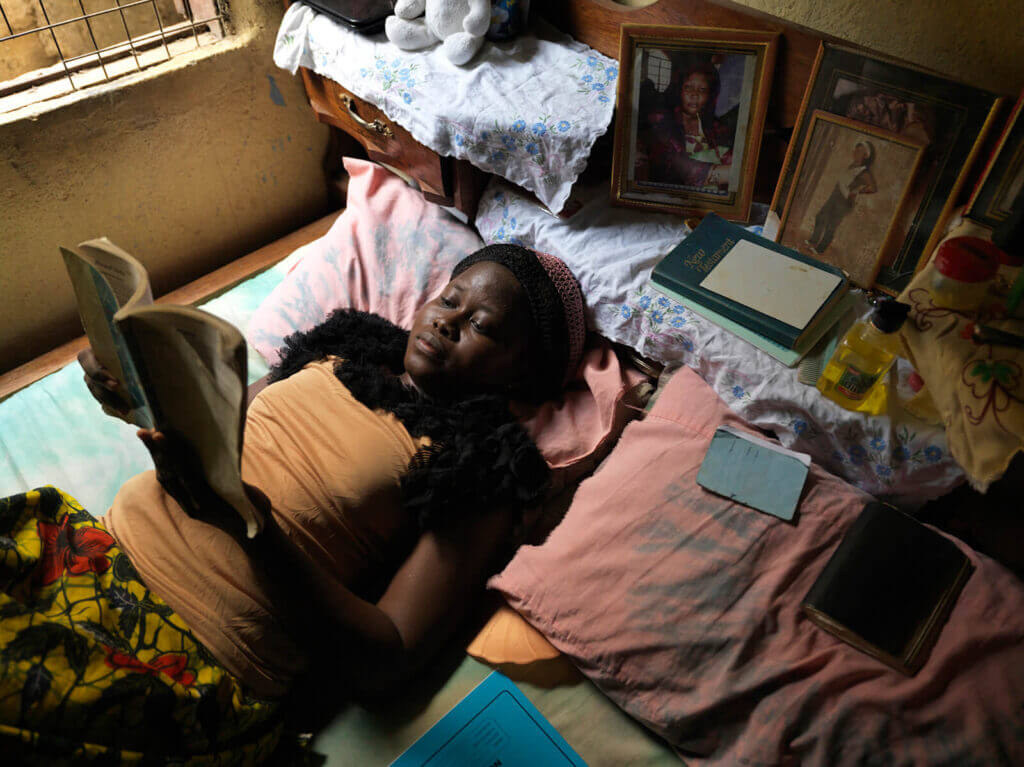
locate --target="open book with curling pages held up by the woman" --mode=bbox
[60,238,262,538]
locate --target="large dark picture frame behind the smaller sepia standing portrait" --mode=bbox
[771,44,1005,295]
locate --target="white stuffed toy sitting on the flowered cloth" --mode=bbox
[384,0,490,67]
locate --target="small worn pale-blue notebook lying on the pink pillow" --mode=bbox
[697,426,811,521]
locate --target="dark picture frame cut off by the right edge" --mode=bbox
[964,92,1024,229]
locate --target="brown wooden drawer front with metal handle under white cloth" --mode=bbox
[301,68,483,216]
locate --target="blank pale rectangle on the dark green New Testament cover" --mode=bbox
[700,240,843,330]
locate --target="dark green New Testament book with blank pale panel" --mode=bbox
[651,213,848,349]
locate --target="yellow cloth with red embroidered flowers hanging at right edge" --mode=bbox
[899,257,1024,492]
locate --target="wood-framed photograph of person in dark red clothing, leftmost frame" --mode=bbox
[611,25,778,221]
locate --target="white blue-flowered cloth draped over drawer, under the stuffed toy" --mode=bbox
[273,3,618,212]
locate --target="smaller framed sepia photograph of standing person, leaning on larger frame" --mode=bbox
[776,110,927,288]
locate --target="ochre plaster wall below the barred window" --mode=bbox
[0,0,328,372]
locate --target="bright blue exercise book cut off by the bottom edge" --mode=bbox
[391,671,587,767]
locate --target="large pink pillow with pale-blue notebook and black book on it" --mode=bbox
[490,369,1024,765]
